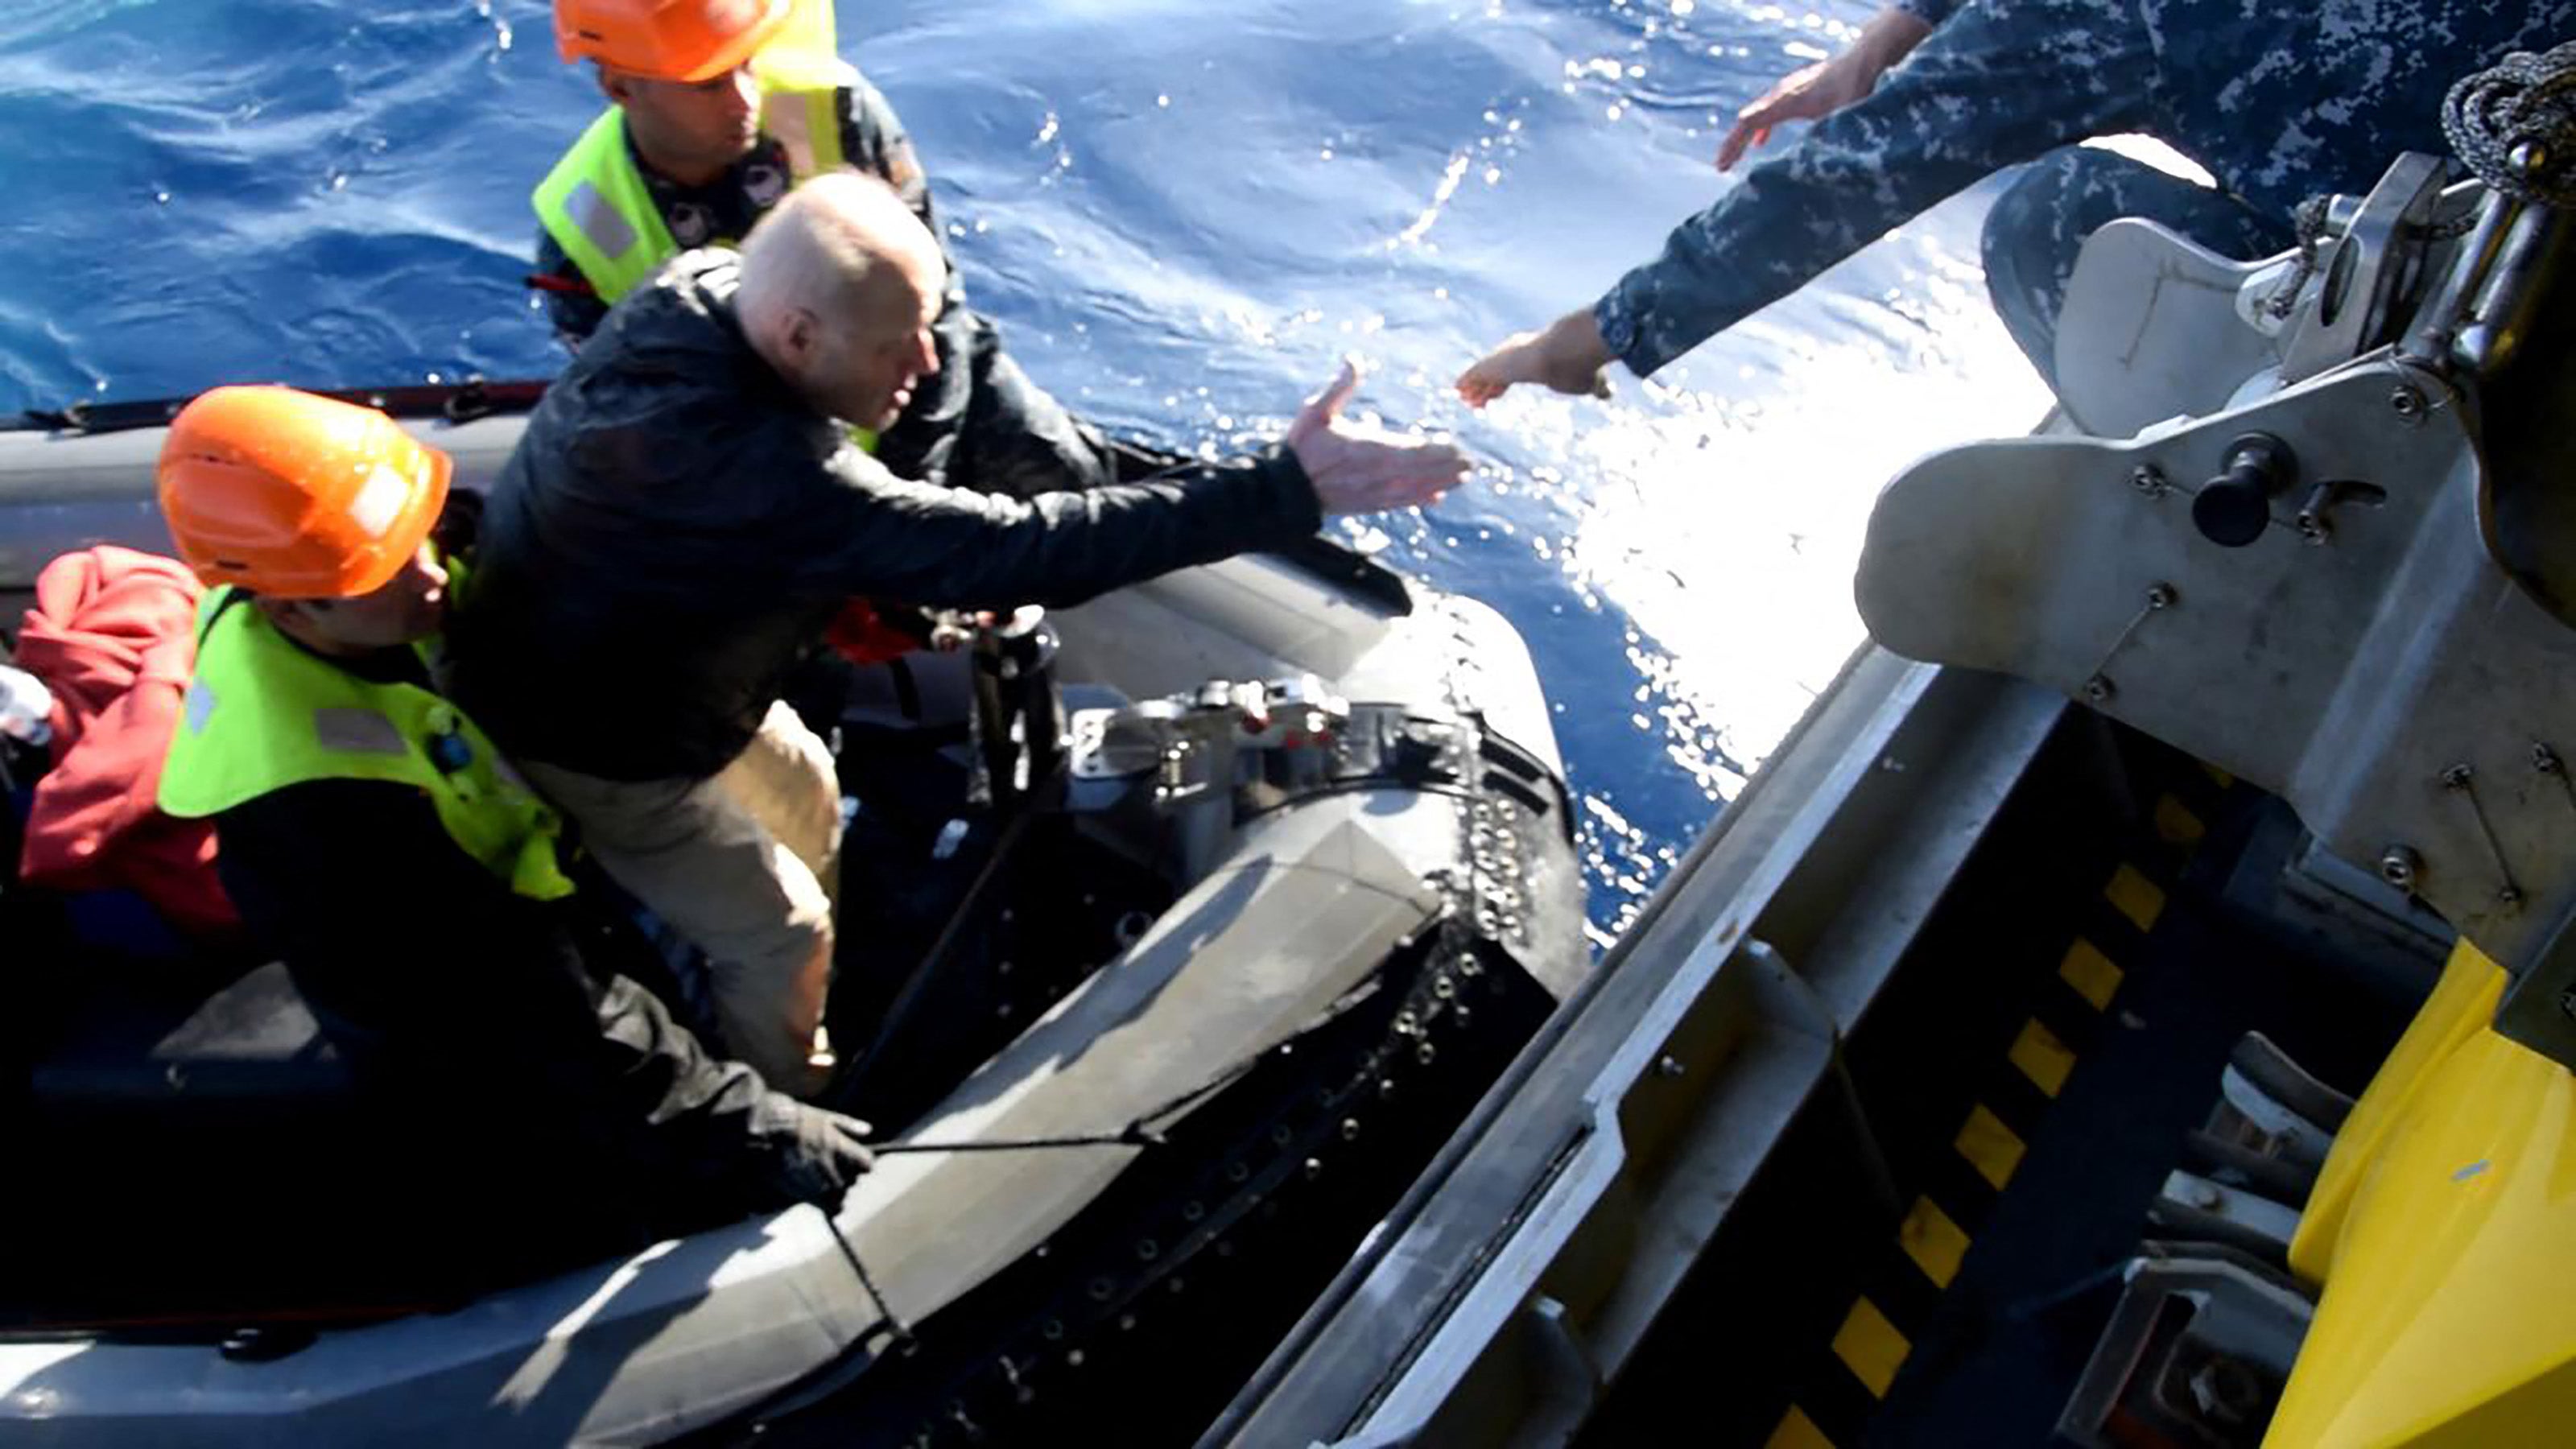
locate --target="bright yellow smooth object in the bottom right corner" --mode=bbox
[2264,941,2576,1449]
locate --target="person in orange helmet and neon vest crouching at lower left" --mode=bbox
[159,386,868,1271]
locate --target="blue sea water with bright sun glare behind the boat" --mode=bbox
[0,0,2043,939]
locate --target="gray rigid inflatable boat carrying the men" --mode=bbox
[0,384,1589,1444]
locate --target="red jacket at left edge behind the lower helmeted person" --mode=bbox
[18,547,240,936]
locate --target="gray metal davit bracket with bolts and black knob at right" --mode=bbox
[1857,157,2576,1065]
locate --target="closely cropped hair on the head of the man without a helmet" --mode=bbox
[734,170,940,341]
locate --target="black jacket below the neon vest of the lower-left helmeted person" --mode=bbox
[217,781,850,1276]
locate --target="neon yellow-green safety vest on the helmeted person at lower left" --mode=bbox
[159,588,572,900]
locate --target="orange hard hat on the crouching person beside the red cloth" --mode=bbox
[159,386,453,598]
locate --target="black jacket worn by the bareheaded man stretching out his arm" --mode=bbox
[448,250,1322,778]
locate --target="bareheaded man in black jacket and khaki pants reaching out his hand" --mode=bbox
[453,173,1466,1091]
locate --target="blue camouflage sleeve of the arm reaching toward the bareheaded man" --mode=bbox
[1592,0,2153,377]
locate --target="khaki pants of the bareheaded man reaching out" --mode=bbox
[520,704,840,1096]
